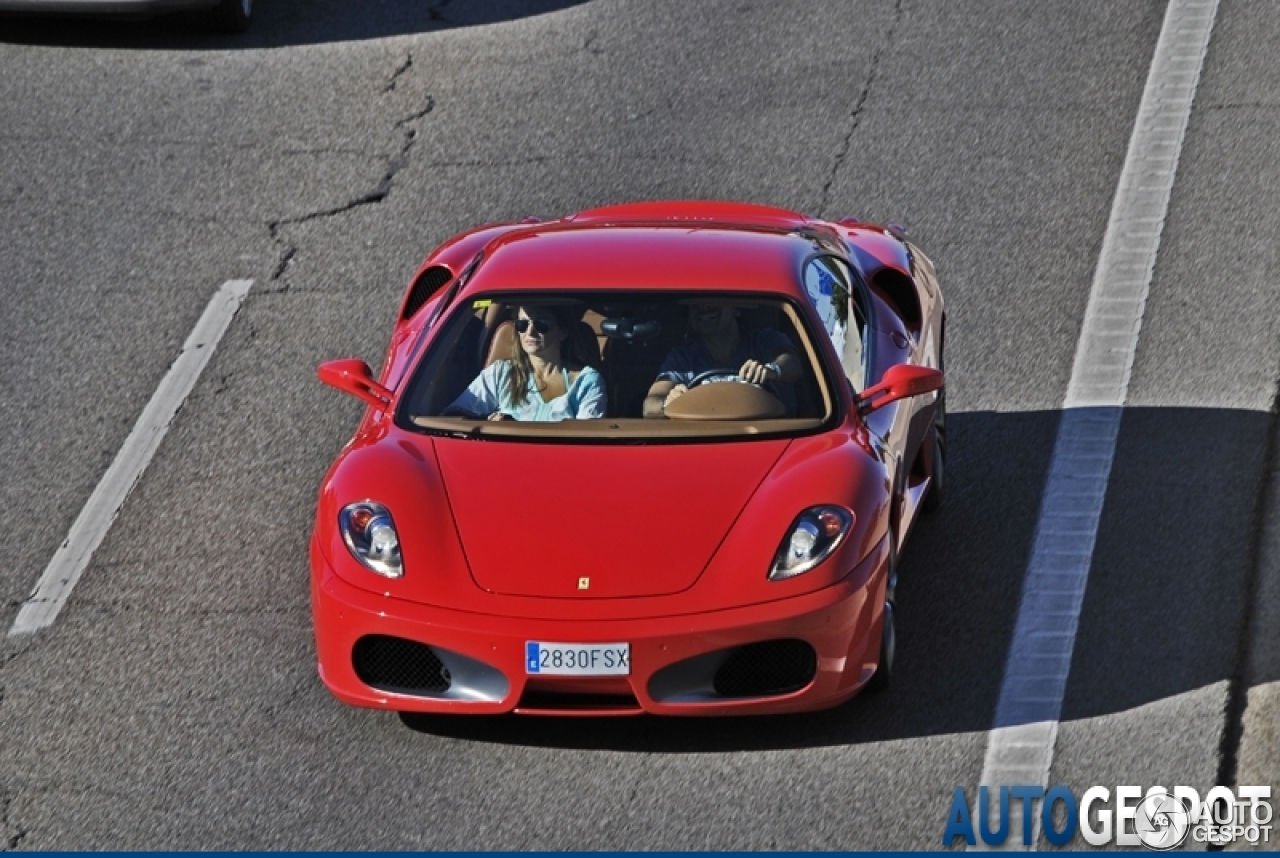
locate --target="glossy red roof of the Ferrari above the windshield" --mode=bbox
[466,220,815,296]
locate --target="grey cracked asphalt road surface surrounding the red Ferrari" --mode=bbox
[0,0,1280,849]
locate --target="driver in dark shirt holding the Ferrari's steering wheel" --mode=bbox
[644,301,803,417]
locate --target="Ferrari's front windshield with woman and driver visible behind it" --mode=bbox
[396,291,838,443]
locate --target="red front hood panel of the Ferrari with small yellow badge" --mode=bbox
[434,438,787,598]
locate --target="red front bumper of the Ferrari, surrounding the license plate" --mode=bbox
[311,543,887,716]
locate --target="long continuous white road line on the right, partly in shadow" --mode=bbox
[979,0,1217,845]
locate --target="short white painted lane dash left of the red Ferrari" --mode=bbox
[9,280,253,638]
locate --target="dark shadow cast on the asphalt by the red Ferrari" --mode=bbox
[402,409,1280,753]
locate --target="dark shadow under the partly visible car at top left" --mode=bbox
[0,0,586,50]
